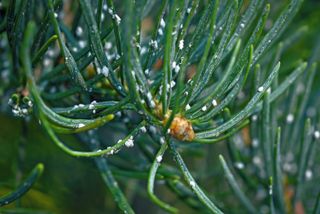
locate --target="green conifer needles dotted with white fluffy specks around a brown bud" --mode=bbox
[0,0,320,213]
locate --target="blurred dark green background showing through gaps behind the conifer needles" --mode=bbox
[0,0,320,214]
